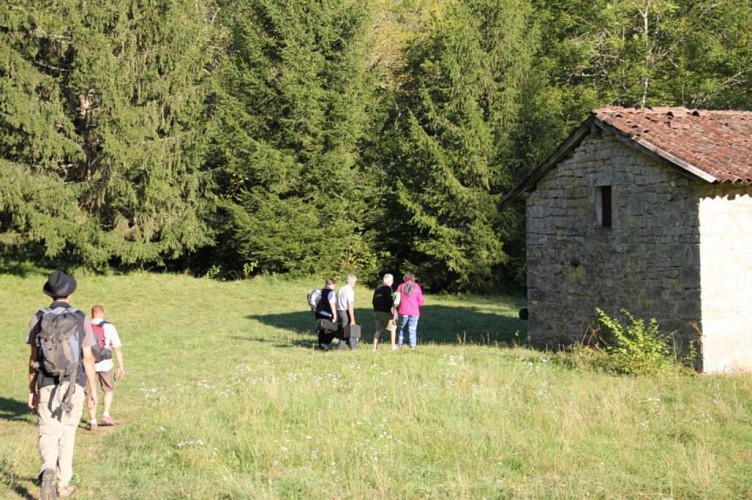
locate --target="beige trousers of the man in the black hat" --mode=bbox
[37,382,84,486]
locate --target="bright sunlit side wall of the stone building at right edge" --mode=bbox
[700,186,752,373]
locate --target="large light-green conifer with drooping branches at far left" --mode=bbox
[0,0,216,266]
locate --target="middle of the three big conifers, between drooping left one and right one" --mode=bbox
[210,0,378,274]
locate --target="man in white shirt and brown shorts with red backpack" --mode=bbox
[86,305,125,431]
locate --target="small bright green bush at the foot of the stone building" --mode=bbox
[595,308,682,375]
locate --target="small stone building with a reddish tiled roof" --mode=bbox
[507,107,752,372]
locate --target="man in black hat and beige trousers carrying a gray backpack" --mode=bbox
[26,270,97,500]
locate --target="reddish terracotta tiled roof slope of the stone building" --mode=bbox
[593,107,752,183]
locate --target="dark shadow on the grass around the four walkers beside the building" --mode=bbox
[247,305,527,346]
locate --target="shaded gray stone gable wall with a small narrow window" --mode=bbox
[527,132,706,352]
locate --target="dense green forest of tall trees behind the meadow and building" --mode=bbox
[0,0,752,291]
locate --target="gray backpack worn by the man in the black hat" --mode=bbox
[37,307,84,413]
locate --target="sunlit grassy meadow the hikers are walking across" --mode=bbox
[0,268,752,499]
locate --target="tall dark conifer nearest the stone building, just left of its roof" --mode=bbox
[378,0,532,289]
